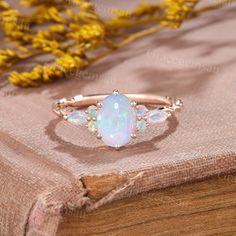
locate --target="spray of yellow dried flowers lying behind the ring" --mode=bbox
[0,0,230,87]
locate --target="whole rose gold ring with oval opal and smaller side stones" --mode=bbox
[53,90,183,149]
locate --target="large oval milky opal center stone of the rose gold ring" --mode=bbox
[97,94,136,147]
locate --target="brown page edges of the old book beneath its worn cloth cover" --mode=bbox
[57,173,236,236]
